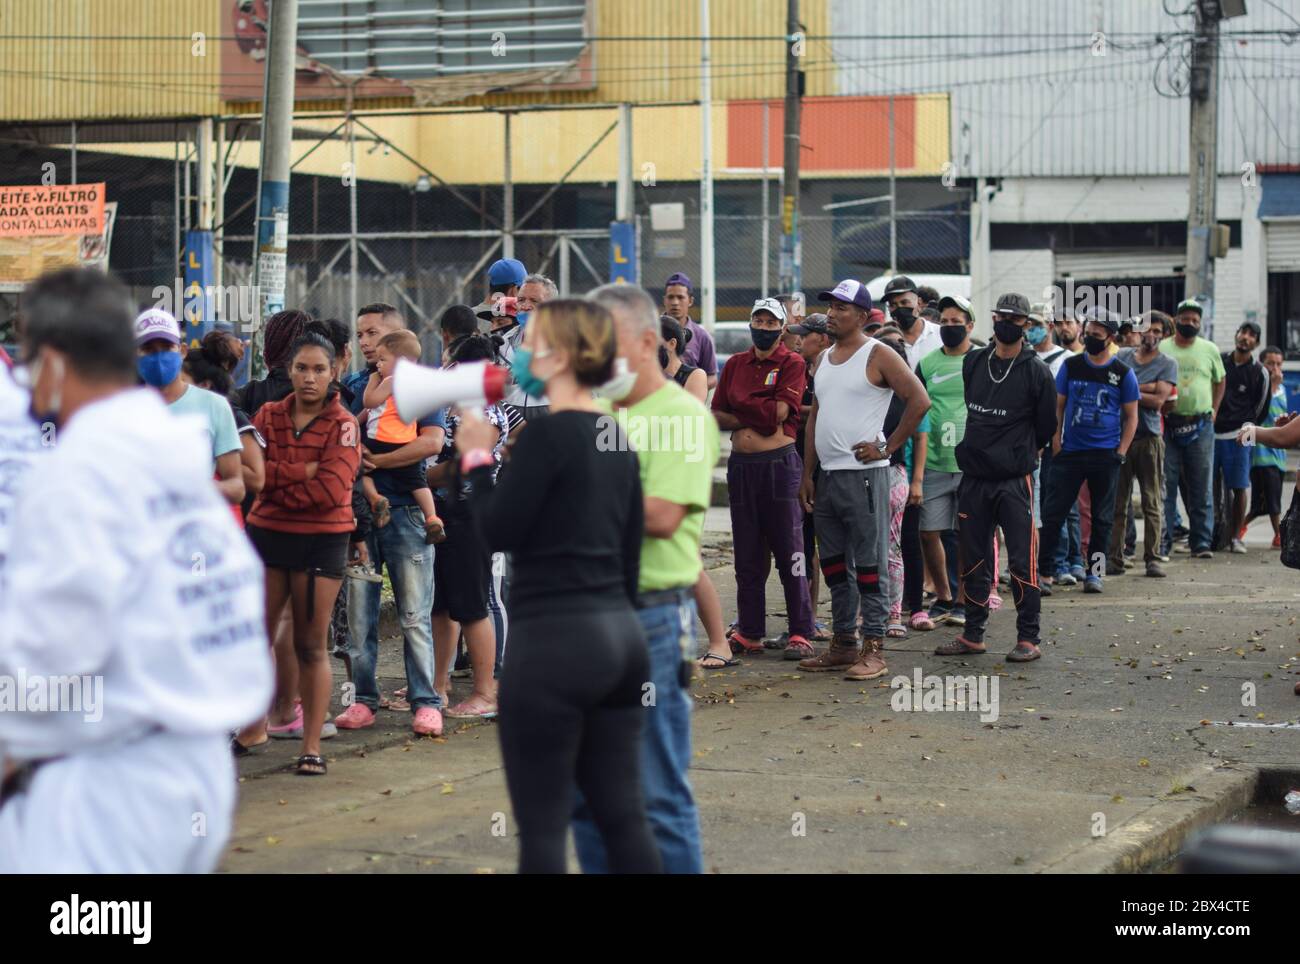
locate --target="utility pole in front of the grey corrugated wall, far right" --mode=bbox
[1184,0,1222,328]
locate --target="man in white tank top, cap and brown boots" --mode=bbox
[800,279,930,681]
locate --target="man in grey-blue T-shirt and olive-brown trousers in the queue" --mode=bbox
[1106,312,1178,578]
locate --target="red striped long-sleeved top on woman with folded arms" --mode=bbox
[248,395,361,534]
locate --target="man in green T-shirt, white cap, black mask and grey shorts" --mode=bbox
[917,296,975,626]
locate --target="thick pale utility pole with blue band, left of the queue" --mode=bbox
[248,0,299,378]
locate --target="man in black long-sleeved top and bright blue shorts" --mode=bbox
[1214,321,1271,553]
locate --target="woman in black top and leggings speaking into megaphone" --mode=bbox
[456,299,660,873]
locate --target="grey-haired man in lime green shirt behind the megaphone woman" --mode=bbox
[573,285,720,873]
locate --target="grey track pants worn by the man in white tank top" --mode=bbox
[813,465,892,639]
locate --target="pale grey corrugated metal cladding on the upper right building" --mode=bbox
[831,0,1300,177]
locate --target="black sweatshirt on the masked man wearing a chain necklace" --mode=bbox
[957,344,1057,481]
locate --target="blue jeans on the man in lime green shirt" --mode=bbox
[573,592,703,873]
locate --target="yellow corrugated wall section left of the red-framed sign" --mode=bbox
[0,0,221,121]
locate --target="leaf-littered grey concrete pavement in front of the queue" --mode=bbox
[224,522,1300,873]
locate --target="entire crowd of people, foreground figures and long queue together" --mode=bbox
[0,259,1300,873]
